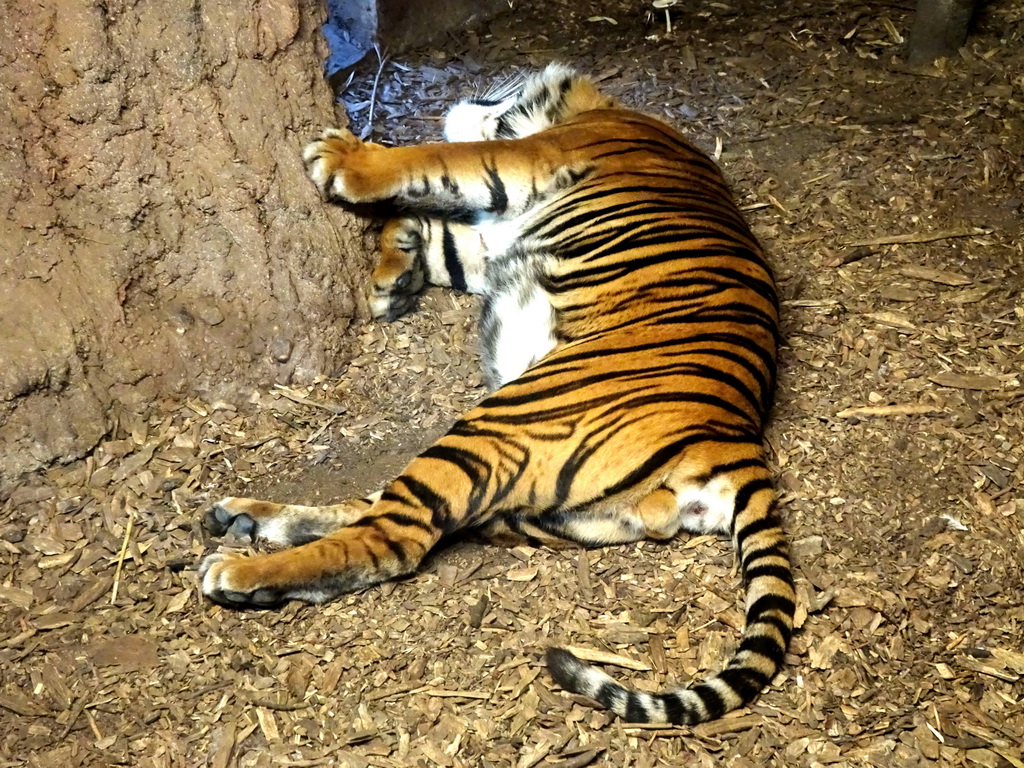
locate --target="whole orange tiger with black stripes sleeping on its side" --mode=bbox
[200,65,795,724]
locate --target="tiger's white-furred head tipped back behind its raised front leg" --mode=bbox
[444,63,616,141]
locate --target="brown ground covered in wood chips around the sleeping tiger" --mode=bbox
[0,0,1024,768]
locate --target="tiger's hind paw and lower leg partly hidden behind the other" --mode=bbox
[203,494,380,547]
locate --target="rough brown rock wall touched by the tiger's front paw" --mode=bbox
[0,0,370,481]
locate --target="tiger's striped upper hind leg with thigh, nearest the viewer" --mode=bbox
[200,406,671,606]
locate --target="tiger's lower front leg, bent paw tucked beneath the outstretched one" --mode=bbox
[369,216,486,323]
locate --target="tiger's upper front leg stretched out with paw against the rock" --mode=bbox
[303,128,577,215]
